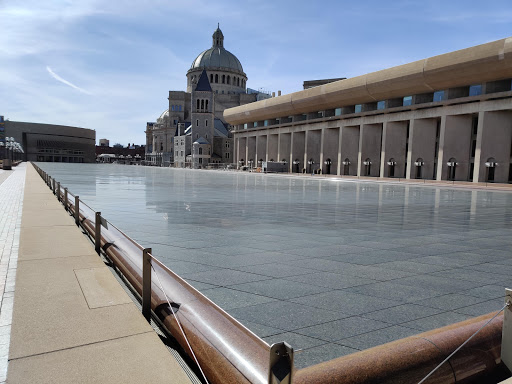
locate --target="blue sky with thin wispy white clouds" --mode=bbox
[0,0,512,145]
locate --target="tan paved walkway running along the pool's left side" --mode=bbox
[5,165,191,384]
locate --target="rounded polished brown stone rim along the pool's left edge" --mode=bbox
[32,164,293,384]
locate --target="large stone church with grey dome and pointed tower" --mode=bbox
[146,26,270,168]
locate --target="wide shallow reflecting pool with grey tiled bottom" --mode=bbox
[38,163,512,368]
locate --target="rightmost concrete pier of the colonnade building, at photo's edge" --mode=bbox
[473,111,512,183]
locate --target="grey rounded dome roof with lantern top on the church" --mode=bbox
[189,27,244,73]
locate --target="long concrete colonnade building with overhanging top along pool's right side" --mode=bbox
[224,38,512,183]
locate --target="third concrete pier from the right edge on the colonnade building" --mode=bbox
[405,119,437,179]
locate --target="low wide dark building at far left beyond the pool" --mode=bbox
[2,118,96,163]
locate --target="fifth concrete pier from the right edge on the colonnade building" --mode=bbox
[358,124,382,177]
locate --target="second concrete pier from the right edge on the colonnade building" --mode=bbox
[438,115,472,181]
